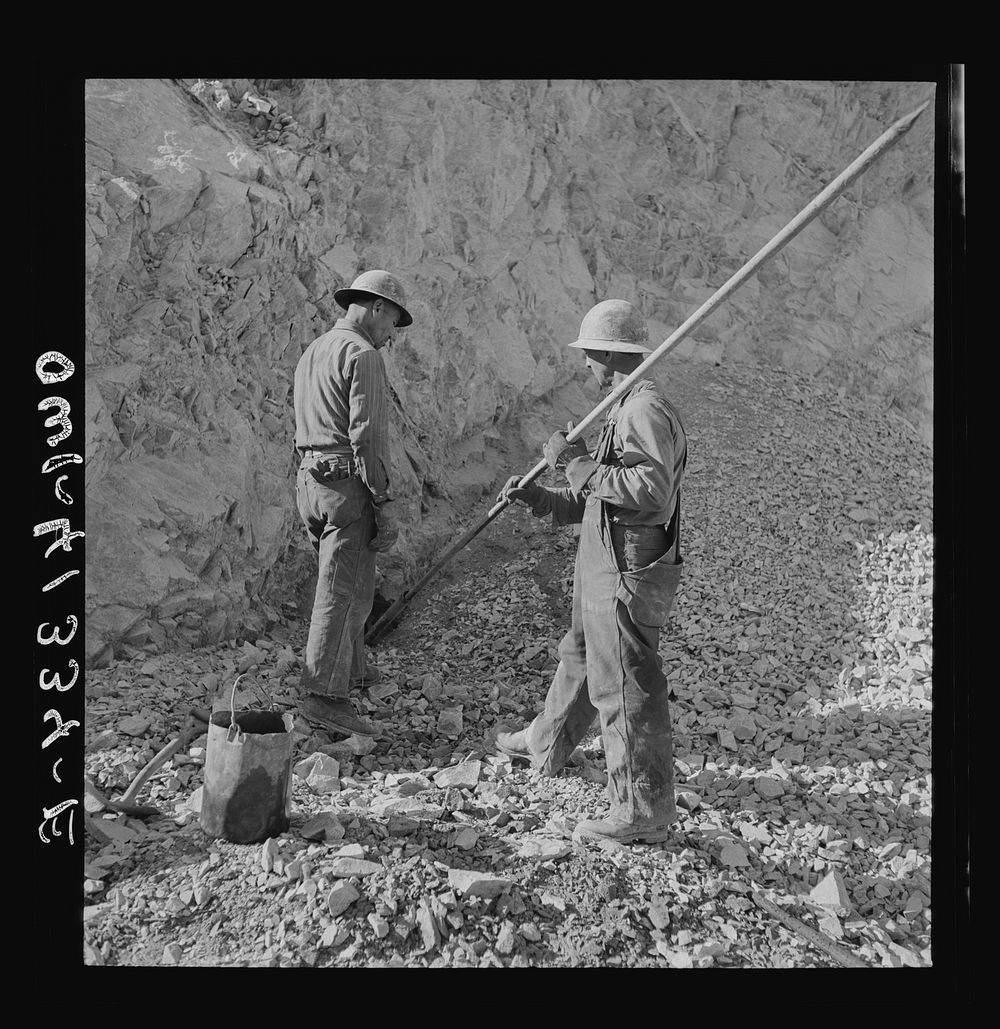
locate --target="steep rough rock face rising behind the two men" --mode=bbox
[85,79,934,664]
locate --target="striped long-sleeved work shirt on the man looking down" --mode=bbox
[294,318,389,503]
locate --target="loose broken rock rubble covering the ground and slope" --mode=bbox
[83,366,933,968]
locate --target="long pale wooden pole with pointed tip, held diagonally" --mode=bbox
[365,100,930,643]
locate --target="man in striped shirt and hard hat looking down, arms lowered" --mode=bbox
[294,270,413,736]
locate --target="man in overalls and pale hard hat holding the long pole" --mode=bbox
[496,300,687,843]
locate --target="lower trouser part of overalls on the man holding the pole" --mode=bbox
[526,497,682,823]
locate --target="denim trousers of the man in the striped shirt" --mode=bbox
[295,452,376,699]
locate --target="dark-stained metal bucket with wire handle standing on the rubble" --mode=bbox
[201,676,294,843]
